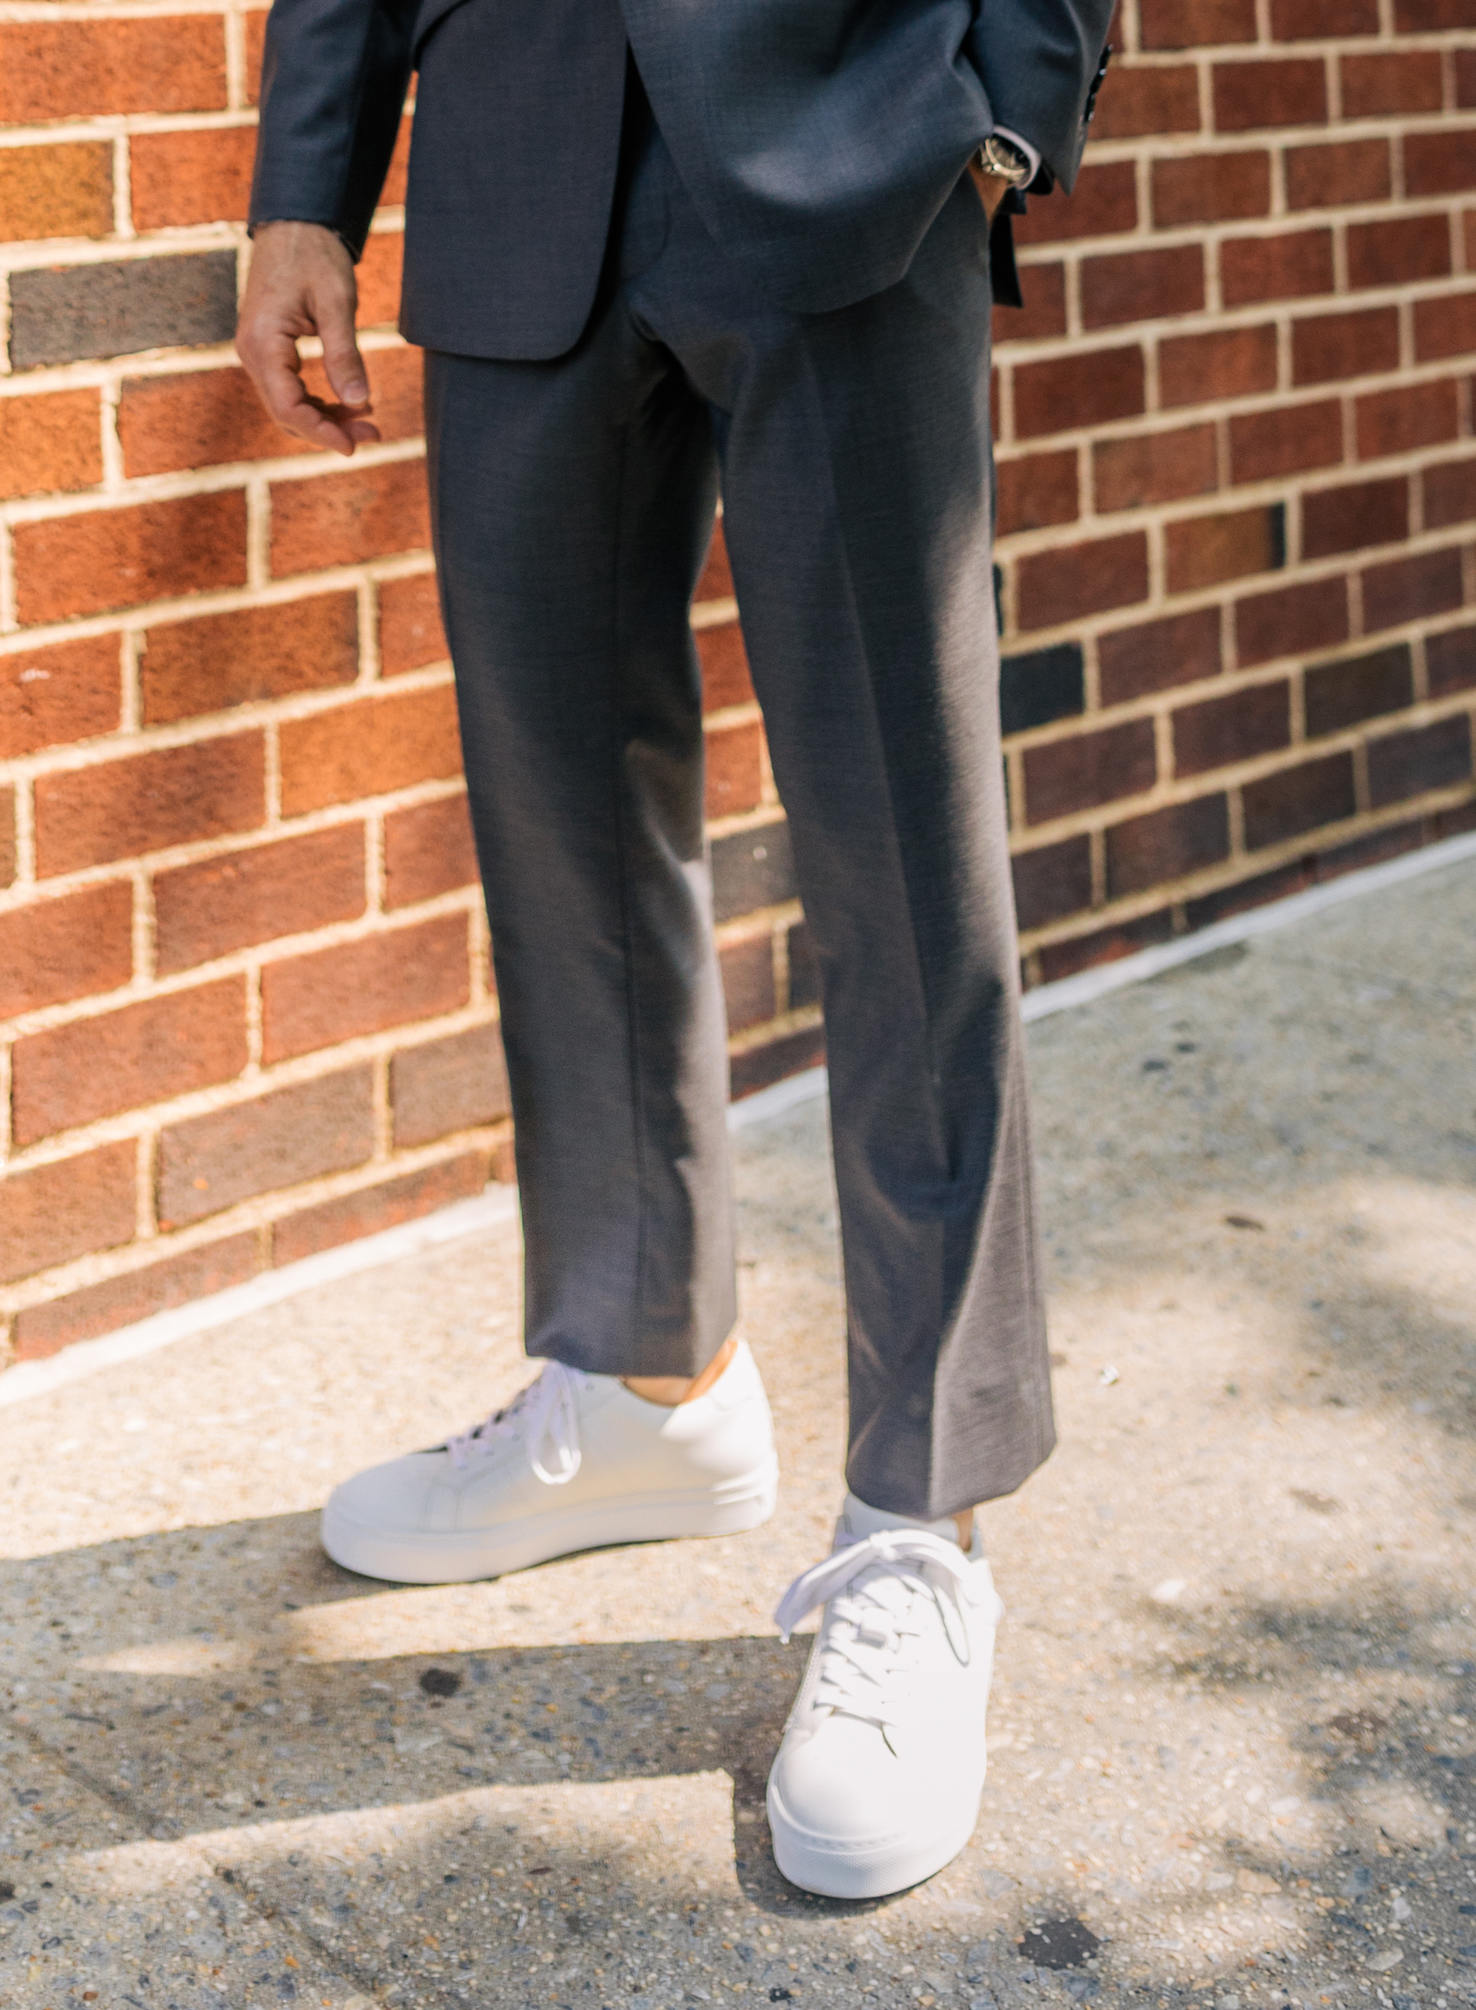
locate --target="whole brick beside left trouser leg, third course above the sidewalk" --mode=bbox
[261,915,471,1063]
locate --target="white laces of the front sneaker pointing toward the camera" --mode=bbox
[774,1528,971,1735]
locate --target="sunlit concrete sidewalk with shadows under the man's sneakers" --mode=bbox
[0,862,1476,2010]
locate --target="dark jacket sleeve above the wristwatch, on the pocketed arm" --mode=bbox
[969,0,1112,191]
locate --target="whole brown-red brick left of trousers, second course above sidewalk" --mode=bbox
[157,1067,374,1230]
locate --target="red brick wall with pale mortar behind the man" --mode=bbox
[0,0,1476,1357]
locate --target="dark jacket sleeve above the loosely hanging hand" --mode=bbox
[249,0,416,259]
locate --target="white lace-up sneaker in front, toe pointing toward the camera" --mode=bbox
[768,1493,1003,1897]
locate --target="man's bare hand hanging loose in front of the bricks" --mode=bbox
[235,223,380,454]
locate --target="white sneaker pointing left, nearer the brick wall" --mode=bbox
[322,1341,778,1584]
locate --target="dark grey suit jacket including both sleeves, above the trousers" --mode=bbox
[251,0,1112,358]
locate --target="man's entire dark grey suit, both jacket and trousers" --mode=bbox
[255,0,1106,1516]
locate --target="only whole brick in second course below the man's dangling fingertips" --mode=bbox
[139,593,358,726]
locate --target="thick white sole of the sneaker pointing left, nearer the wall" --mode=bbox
[322,1459,778,1584]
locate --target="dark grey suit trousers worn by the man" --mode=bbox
[426,96,1054,1516]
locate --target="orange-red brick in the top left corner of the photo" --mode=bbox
[0,14,225,125]
